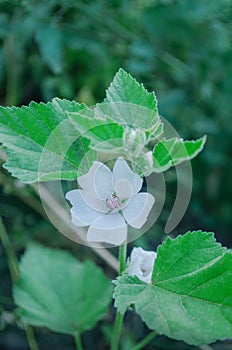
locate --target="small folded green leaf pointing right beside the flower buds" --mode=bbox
[153,136,206,173]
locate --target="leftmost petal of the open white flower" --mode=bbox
[65,190,101,227]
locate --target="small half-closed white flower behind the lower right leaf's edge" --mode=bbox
[128,248,156,283]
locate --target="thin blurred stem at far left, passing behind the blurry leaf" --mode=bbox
[0,217,39,350]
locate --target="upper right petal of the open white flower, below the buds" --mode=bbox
[113,157,143,194]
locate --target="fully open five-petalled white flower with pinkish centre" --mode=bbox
[66,158,155,245]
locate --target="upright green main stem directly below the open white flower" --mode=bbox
[111,242,127,350]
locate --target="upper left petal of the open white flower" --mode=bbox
[78,162,114,200]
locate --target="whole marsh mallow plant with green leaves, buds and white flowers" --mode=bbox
[0,69,232,350]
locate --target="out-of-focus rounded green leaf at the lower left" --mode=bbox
[13,245,112,335]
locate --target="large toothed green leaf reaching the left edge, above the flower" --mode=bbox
[0,99,95,183]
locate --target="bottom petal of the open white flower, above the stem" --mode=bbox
[87,213,127,245]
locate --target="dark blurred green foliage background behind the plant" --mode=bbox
[0,0,232,350]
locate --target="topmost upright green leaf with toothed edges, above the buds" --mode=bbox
[95,69,160,130]
